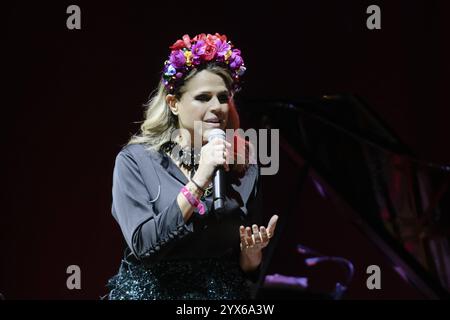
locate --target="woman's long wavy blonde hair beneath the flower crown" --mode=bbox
[127,63,249,173]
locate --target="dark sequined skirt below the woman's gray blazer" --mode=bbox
[107,258,250,300]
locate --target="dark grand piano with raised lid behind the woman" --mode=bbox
[238,95,450,299]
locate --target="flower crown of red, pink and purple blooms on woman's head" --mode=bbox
[162,33,246,93]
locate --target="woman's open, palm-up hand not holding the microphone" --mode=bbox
[239,214,278,253]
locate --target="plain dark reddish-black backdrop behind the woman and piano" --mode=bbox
[0,0,450,299]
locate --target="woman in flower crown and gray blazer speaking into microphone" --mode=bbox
[108,33,278,300]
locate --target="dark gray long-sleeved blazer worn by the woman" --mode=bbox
[112,144,262,263]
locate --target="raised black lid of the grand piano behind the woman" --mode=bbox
[237,95,450,298]
